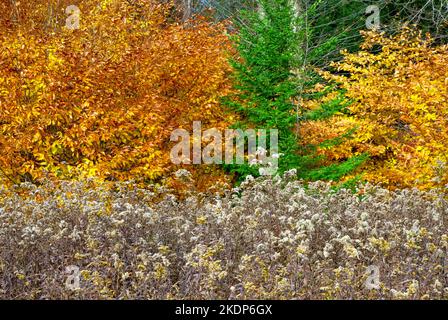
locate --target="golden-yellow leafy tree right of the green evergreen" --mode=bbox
[301,28,448,189]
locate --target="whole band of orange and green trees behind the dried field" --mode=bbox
[0,0,448,189]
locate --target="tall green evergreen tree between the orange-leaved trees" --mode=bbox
[225,0,366,180]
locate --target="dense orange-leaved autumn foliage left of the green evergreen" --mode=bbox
[0,0,234,189]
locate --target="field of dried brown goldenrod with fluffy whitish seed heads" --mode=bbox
[0,173,448,299]
